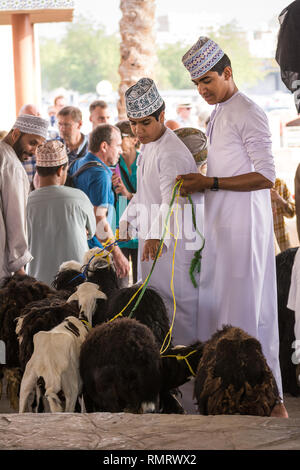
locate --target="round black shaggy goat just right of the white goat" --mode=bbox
[80,318,161,413]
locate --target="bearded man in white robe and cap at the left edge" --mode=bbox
[0,114,48,279]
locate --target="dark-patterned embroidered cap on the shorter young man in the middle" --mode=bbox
[125,78,164,118]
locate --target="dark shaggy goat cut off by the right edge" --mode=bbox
[276,248,300,396]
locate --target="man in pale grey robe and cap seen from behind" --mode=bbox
[27,140,96,285]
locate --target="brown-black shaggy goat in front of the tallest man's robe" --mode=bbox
[194,326,279,416]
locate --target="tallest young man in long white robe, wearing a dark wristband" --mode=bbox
[178,37,287,417]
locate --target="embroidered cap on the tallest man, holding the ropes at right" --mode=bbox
[182,36,224,79]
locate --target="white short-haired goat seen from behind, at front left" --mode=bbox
[19,316,89,413]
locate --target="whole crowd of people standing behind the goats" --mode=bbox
[0,37,296,416]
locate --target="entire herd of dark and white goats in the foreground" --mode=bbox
[0,248,300,416]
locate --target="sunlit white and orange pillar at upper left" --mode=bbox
[11,13,37,115]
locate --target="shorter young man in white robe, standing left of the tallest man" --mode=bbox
[120,78,203,412]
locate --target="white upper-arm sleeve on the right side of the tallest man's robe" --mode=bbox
[240,106,276,183]
